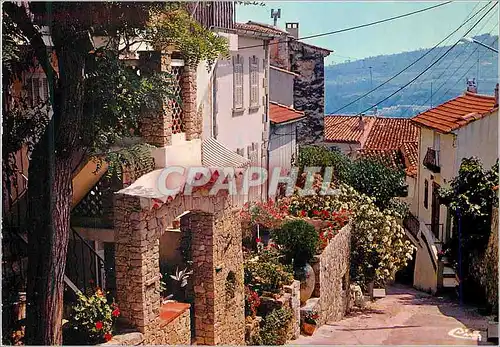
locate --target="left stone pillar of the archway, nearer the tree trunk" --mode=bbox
[114,195,161,334]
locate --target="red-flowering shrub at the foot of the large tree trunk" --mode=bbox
[67,289,120,344]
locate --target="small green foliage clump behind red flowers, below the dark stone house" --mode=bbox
[297,146,351,181]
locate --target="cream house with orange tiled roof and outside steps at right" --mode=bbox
[411,84,498,292]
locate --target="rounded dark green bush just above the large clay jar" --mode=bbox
[271,219,319,266]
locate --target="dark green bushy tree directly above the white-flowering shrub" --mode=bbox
[345,157,406,209]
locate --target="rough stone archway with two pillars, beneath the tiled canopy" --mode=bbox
[114,190,245,345]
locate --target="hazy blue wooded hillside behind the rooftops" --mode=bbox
[325,34,498,117]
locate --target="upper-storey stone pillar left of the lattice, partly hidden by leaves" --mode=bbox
[139,51,172,147]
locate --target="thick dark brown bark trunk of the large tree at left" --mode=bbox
[26,38,85,345]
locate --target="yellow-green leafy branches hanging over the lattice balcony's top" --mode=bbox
[147,3,229,67]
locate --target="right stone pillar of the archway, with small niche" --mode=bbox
[191,210,245,345]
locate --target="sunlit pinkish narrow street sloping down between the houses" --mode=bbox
[293,284,489,345]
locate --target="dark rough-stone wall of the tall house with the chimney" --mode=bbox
[289,40,327,144]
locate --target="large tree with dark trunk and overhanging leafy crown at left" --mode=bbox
[2,2,228,345]
